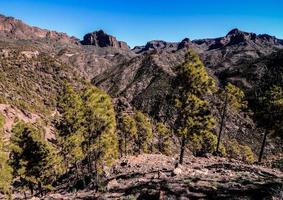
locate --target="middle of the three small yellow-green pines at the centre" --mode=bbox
[135,112,153,153]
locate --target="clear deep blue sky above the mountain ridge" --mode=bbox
[0,0,283,47]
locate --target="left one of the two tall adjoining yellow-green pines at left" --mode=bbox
[57,83,85,169]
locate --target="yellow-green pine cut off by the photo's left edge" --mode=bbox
[0,114,12,198]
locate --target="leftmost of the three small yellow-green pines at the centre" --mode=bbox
[119,113,137,156]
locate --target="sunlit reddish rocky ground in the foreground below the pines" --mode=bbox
[18,154,283,200]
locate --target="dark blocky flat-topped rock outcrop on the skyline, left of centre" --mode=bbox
[81,30,130,50]
